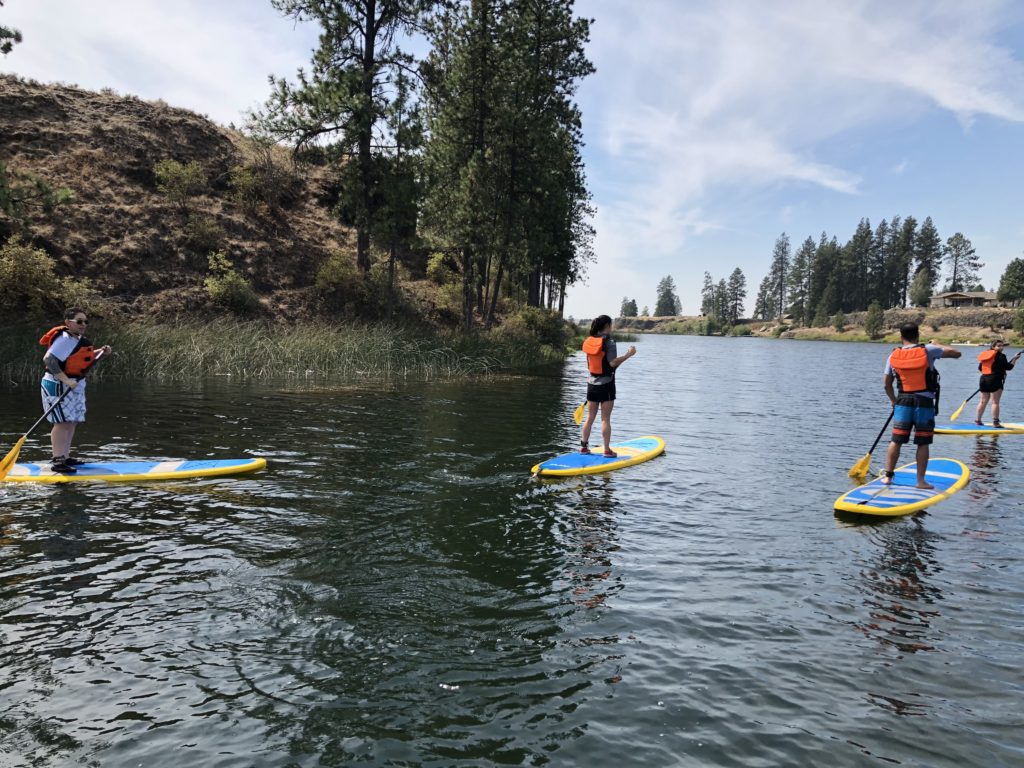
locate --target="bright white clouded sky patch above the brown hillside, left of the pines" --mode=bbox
[0,0,315,123]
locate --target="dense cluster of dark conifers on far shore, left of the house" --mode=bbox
[754,216,984,326]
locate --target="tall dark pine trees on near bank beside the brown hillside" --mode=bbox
[250,0,594,329]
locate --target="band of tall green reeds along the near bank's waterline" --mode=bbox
[0,319,563,381]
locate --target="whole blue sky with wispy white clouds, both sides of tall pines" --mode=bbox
[0,0,1024,317]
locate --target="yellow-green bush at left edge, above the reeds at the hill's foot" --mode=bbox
[0,236,98,321]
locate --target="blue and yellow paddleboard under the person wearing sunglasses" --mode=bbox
[4,459,266,482]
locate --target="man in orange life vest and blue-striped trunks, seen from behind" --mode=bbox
[882,323,961,488]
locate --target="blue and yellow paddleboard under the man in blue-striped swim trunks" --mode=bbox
[836,459,971,517]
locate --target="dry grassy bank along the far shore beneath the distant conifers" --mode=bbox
[615,307,1024,345]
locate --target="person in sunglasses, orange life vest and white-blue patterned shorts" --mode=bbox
[39,307,111,474]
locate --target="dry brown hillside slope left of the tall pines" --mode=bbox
[0,76,354,316]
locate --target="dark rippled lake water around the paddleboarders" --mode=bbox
[0,336,1024,768]
